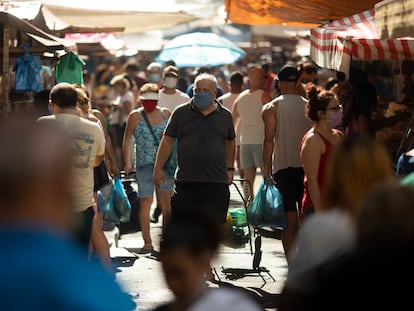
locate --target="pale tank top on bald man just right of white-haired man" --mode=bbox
[237,90,264,145]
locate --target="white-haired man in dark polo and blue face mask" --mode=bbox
[154,73,235,229]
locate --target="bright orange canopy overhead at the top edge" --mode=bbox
[225,0,379,27]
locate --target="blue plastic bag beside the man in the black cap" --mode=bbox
[247,181,286,228]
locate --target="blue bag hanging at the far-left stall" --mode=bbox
[15,43,42,92]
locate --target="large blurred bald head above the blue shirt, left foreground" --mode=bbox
[0,119,72,229]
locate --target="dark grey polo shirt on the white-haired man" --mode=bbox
[165,100,236,184]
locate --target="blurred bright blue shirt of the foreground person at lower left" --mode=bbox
[0,224,136,311]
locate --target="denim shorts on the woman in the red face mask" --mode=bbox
[135,164,174,198]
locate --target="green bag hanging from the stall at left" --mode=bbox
[56,52,85,84]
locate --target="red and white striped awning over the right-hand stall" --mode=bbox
[310,9,414,73]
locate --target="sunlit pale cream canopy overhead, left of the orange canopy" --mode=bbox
[43,5,196,33]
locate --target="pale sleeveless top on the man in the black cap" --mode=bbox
[273,94,311,172]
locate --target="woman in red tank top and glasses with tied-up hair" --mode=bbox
[300,87,343,216]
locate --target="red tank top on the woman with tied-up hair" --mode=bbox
[302,129,338,212]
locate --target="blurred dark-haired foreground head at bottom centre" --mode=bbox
[160,210,221,301]
